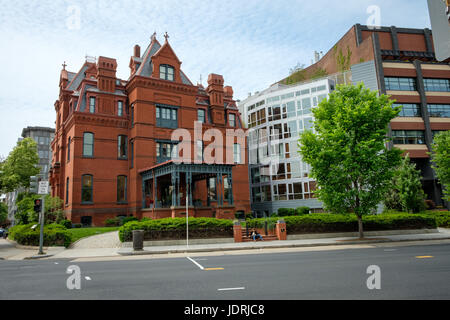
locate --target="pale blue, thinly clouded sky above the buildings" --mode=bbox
[0,0,430,157]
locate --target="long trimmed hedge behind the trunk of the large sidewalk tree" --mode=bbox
[247,213,437,234]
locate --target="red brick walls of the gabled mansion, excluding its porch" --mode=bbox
[50,36,250,226]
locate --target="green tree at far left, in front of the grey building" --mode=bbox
[0,138,40,192]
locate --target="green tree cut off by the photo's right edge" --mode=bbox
[430,131,450,201]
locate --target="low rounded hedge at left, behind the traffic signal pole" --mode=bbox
[8,223,71,248]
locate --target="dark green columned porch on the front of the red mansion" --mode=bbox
[140,161,239,219]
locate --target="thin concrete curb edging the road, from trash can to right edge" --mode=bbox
[117,236,450,256]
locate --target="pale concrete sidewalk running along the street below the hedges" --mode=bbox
[0,228,450,260]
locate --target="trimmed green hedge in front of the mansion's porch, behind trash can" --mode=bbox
[119,218,233,242]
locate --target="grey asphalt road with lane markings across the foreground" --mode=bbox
[0,243,450,300]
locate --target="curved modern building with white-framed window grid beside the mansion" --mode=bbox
[239,72,351,217]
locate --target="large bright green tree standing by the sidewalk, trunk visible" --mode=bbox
[299,84,401,238]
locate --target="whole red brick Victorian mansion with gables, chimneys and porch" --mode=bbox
[50,35,250,225]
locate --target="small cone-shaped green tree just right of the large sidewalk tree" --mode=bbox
[385,155,425,213]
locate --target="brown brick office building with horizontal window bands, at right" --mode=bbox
[282,24,450,205]
